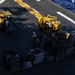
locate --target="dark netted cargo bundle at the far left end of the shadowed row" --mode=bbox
[4,50,21,73]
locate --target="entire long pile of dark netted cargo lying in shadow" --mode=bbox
[4,32,75,73]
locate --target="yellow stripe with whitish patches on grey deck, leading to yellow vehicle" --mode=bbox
[15,0,41,18]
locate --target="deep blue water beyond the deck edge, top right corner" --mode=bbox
[53,0,75,13]
